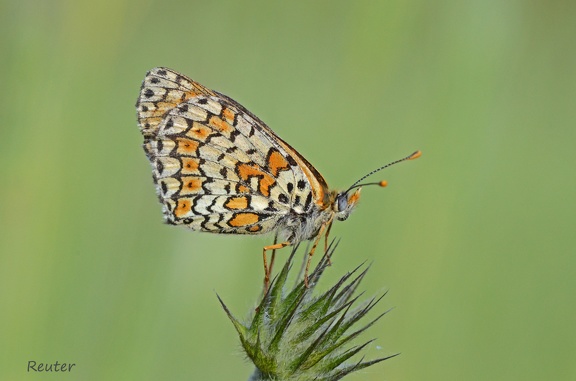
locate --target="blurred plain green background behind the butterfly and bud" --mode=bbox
[0,0,576,381]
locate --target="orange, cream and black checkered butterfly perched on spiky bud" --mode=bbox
[136,68,420,281]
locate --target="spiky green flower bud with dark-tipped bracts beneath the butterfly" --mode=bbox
[218,245,396,381]
